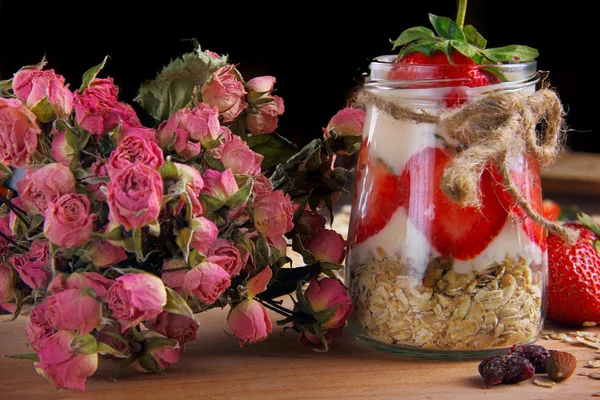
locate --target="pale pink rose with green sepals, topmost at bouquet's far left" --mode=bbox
[12,68,73,122]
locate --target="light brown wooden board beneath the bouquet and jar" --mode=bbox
[0,310,600,400]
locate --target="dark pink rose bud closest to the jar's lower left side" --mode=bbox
[304,278,354,329]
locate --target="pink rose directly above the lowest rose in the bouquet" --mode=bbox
[46,289,102,335]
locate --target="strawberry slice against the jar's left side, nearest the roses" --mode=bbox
[350,155,405,244]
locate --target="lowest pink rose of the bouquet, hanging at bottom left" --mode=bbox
[35,331,98,392]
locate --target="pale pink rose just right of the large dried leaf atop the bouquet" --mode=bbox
[201,65,248,122]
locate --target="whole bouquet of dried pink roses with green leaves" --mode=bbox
[0,41,364,391]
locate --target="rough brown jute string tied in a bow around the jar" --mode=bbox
[353,89,578,244]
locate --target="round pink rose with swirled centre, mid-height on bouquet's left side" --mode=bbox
[44,194,97,249]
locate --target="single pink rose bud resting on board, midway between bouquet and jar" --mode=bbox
[227,299,273,346]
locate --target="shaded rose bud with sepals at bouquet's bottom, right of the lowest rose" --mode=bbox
[135,331,180,372]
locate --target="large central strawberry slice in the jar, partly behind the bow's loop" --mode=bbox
[401,148,508,260]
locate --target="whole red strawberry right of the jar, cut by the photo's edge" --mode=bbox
[547,222,600,325]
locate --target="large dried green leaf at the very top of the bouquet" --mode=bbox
[135,52,227,121]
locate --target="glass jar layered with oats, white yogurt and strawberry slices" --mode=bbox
[346,56,547,358]
